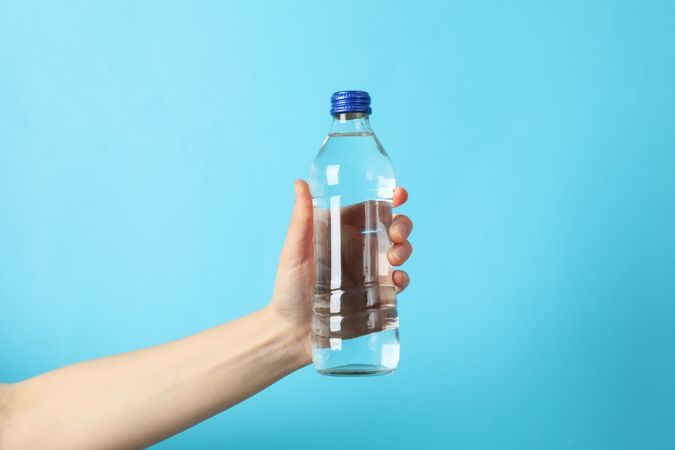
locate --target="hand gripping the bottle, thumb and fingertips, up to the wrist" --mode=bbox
[269,180,413,363]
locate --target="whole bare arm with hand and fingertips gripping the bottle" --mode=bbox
[0,181,412,450]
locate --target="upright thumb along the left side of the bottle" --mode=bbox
[283,180,313,259]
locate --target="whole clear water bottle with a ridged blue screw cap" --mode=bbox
[310,91,399,376]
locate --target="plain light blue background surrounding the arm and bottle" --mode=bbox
[0,1,675,450]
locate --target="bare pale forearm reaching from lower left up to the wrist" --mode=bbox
[4,309,309,449]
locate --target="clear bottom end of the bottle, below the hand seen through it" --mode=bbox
[313,329,400,377]
